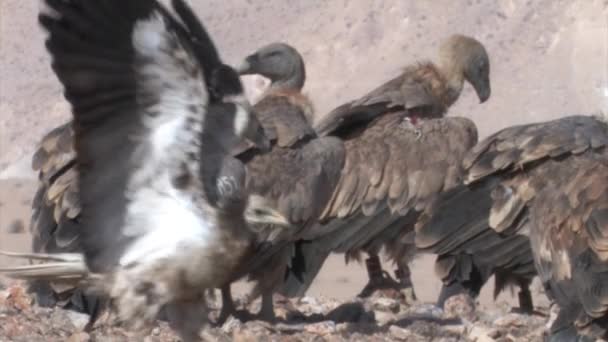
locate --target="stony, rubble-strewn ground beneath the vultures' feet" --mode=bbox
[0,281,548,342]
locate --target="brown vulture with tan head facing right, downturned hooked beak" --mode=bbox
[281,35,491,299]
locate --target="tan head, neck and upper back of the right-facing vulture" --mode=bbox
[316,35,491,135]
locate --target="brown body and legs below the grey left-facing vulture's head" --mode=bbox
[218,89,344,319]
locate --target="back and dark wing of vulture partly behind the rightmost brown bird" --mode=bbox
[416,116,608,316]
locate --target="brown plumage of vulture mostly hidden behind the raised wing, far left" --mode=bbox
[29,122,99,315]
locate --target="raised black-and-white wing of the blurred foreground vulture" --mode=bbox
[40,0,222,271]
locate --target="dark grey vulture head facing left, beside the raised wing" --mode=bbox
[238,43,306,90]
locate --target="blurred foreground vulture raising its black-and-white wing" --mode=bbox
[4,0,290,341]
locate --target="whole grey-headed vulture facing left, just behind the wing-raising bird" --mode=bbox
[218,43,345,322]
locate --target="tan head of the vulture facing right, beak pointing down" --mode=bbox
[439,34,491,103]
